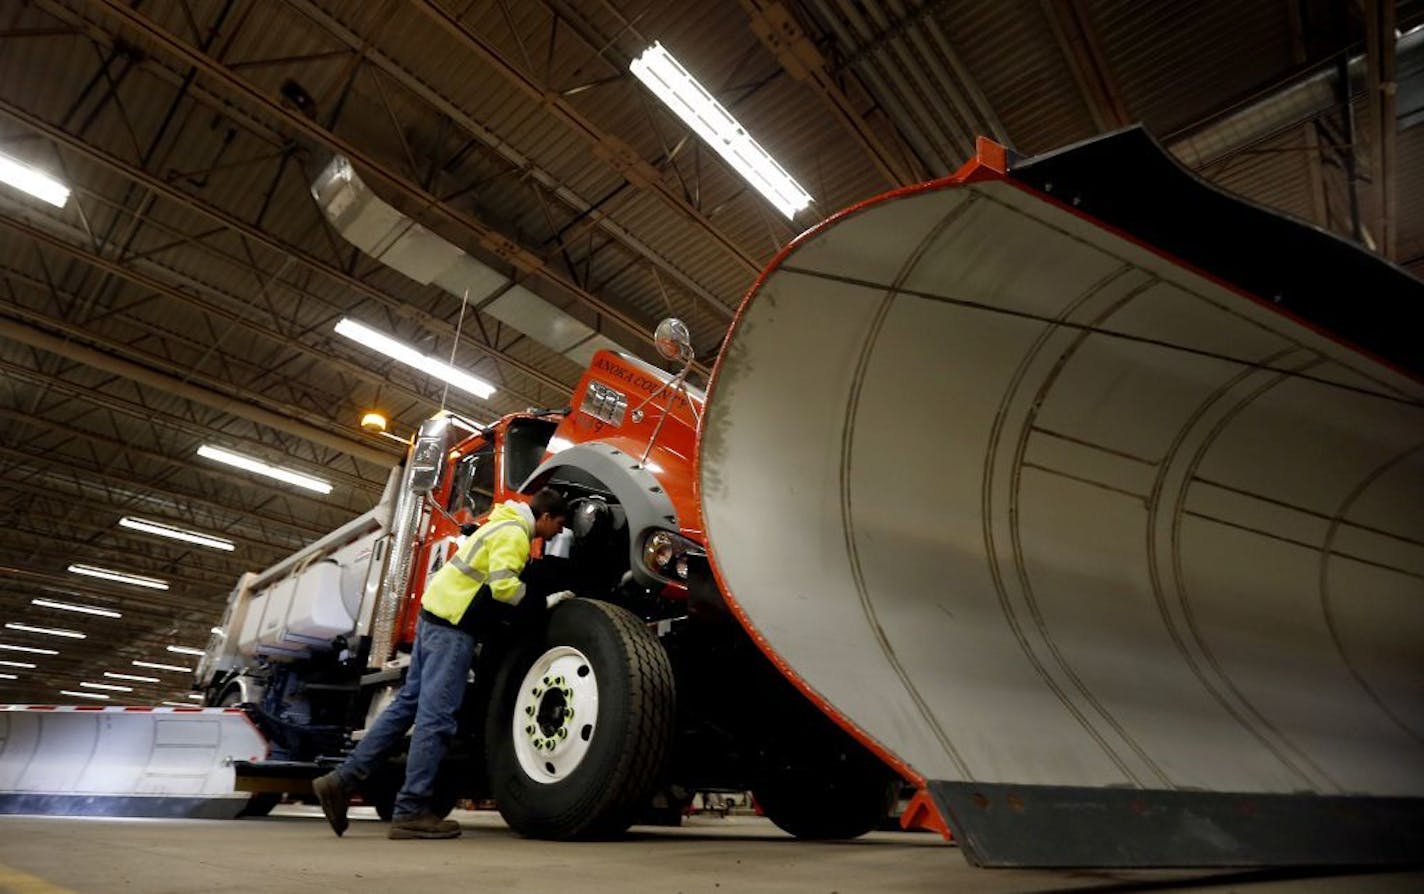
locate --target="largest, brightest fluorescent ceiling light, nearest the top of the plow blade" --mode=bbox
[628,43,810,218]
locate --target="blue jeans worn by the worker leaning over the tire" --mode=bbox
[336,618,474,819]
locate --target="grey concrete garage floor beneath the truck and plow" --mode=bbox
[0,807,1424,894]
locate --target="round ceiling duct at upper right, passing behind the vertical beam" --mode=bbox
[1168,28,1424,168]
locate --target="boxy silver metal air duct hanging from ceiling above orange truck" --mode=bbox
[312,155,632,366]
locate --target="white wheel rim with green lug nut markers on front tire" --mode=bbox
[511,646,598,783]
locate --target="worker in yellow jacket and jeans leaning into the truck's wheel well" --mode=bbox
[312,487,568,838]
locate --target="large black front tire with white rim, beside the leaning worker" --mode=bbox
[486,599,676,840]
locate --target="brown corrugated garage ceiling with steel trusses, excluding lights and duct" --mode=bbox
[0,0,1424,703]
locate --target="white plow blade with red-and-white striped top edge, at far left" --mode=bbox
[0,705,268,819]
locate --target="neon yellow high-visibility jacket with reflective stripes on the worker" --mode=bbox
[420,500,534,625]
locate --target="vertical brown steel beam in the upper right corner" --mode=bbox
[1364,0,1398,261]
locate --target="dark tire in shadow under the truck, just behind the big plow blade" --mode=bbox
[752,754,897,841]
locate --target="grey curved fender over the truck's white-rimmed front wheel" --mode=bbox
[520,443,678,588]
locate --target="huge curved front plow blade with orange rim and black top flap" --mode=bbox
[699,131,1424,866]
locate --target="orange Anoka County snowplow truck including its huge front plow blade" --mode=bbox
[198,130,1424,866]
